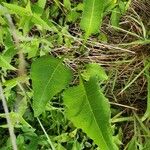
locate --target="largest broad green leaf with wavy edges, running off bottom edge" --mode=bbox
[63,76,118,150]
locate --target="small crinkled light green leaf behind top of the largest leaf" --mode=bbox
[82,63,108,80]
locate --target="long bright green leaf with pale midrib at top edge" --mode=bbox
[80,0,106,38]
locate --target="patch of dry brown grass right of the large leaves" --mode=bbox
[53,0,150,147]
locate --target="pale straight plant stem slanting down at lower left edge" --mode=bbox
[0,83,17,150]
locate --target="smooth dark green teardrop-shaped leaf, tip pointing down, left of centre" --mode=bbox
[31,56,72,116]
